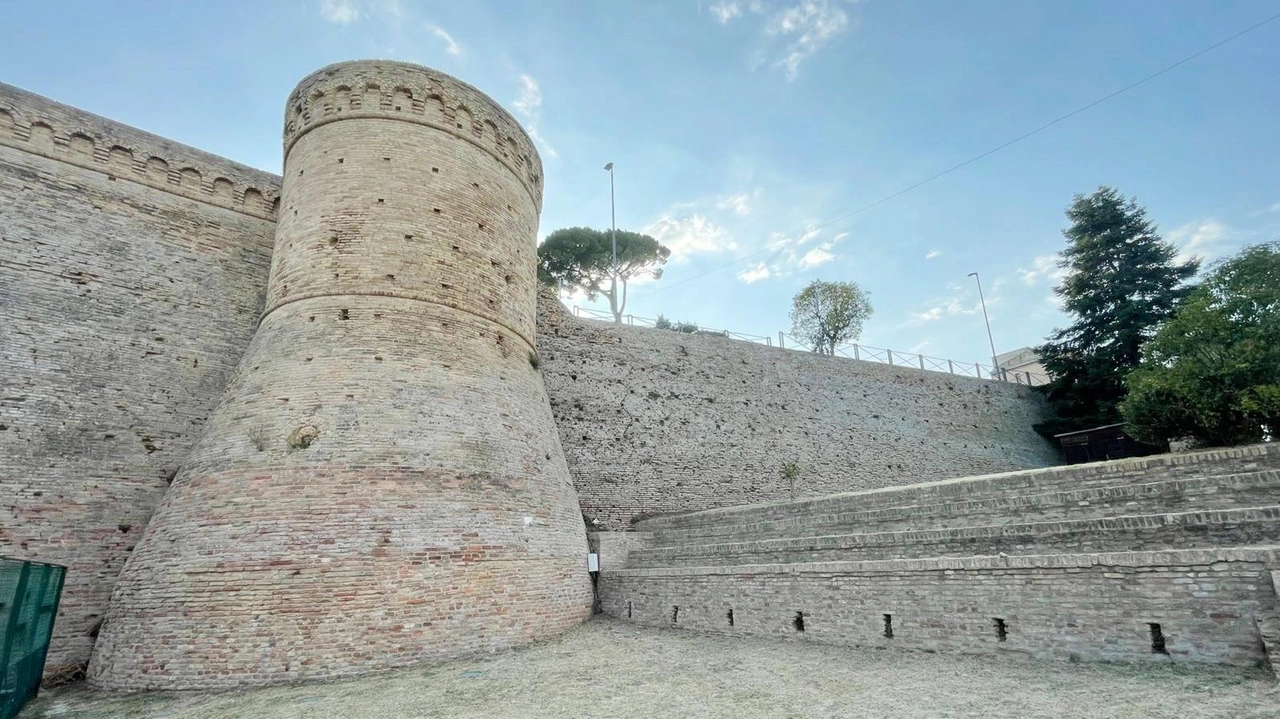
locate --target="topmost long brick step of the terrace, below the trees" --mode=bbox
[635,444,1280,532]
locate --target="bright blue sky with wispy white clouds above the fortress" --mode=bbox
[0,0,1280,361]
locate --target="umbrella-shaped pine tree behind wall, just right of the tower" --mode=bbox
[538,228,671,322]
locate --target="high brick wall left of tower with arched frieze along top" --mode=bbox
[0,84,279,672]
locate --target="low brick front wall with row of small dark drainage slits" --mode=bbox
[600,550,1280,667]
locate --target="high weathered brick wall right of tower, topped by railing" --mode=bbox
[538,292,1059,530]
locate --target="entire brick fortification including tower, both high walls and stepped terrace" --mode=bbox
[0,60,1280,688]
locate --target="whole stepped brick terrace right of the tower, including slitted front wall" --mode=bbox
[591,445,1280,667]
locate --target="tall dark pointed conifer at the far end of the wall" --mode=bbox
[1036,187,1199,436]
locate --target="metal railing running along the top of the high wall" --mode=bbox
[573,306,1048,386]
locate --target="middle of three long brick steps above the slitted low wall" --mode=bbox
[652,470,1280,546]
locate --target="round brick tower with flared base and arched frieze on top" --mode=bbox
[90,61,590,688]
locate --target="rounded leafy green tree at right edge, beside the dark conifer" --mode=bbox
[1120,242,1280,446]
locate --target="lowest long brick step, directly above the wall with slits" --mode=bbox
[627,505,1280,568]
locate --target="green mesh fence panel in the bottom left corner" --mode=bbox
[0,557,67,719]
